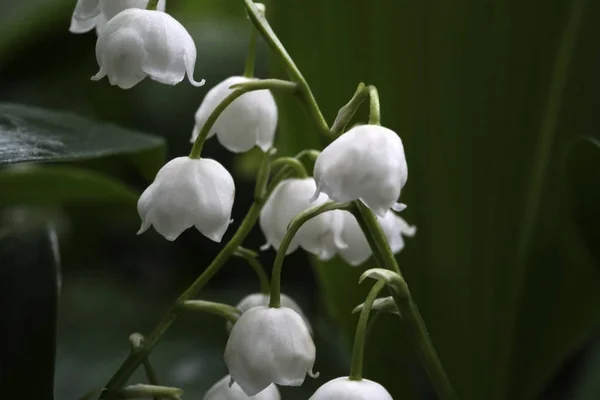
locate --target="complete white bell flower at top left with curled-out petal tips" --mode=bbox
[92,8,204,89]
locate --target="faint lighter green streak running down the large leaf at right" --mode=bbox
[495,0,588,397]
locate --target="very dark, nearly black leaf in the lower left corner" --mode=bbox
[0,223,59,400]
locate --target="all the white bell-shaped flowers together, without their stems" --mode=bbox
[70,0,416,400]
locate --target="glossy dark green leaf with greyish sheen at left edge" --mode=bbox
[0,104,164,177]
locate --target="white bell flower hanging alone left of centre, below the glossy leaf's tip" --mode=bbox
[138,157,235,242]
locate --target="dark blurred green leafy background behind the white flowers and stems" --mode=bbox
[0,0,600,400]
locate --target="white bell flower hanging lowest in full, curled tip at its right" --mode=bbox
[225,306,316,396]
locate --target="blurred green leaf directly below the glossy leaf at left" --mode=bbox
[0,165,139,208]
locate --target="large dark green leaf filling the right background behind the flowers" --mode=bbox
[272,0,600,400]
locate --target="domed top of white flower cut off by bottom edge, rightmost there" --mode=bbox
[308,376,393,400]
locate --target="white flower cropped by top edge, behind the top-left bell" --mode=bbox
[69,0,167,34]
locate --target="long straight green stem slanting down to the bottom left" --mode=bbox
[102,201,263,398]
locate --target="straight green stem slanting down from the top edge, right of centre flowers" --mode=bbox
[244,0,331,137]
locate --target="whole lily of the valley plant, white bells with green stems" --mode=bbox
[70,0,457,400]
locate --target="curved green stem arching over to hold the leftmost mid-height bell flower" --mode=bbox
[190,79,298,159]
